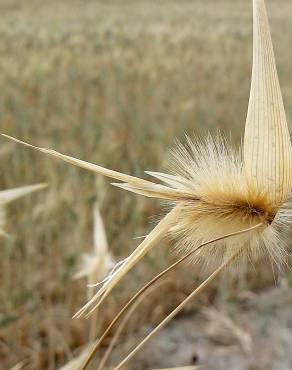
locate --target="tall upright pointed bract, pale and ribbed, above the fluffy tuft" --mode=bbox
[244,0,291,206]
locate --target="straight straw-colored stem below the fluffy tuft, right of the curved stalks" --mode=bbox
[114,244,249,370]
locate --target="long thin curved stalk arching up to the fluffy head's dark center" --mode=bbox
[80,224,262,370]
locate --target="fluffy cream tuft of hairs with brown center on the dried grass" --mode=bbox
[164,136,292,267]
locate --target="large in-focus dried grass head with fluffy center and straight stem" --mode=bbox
[4,0,292,370]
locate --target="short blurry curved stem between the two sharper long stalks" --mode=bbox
[97,280,166,370]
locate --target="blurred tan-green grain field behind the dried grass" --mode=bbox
[0,0,292,370]
